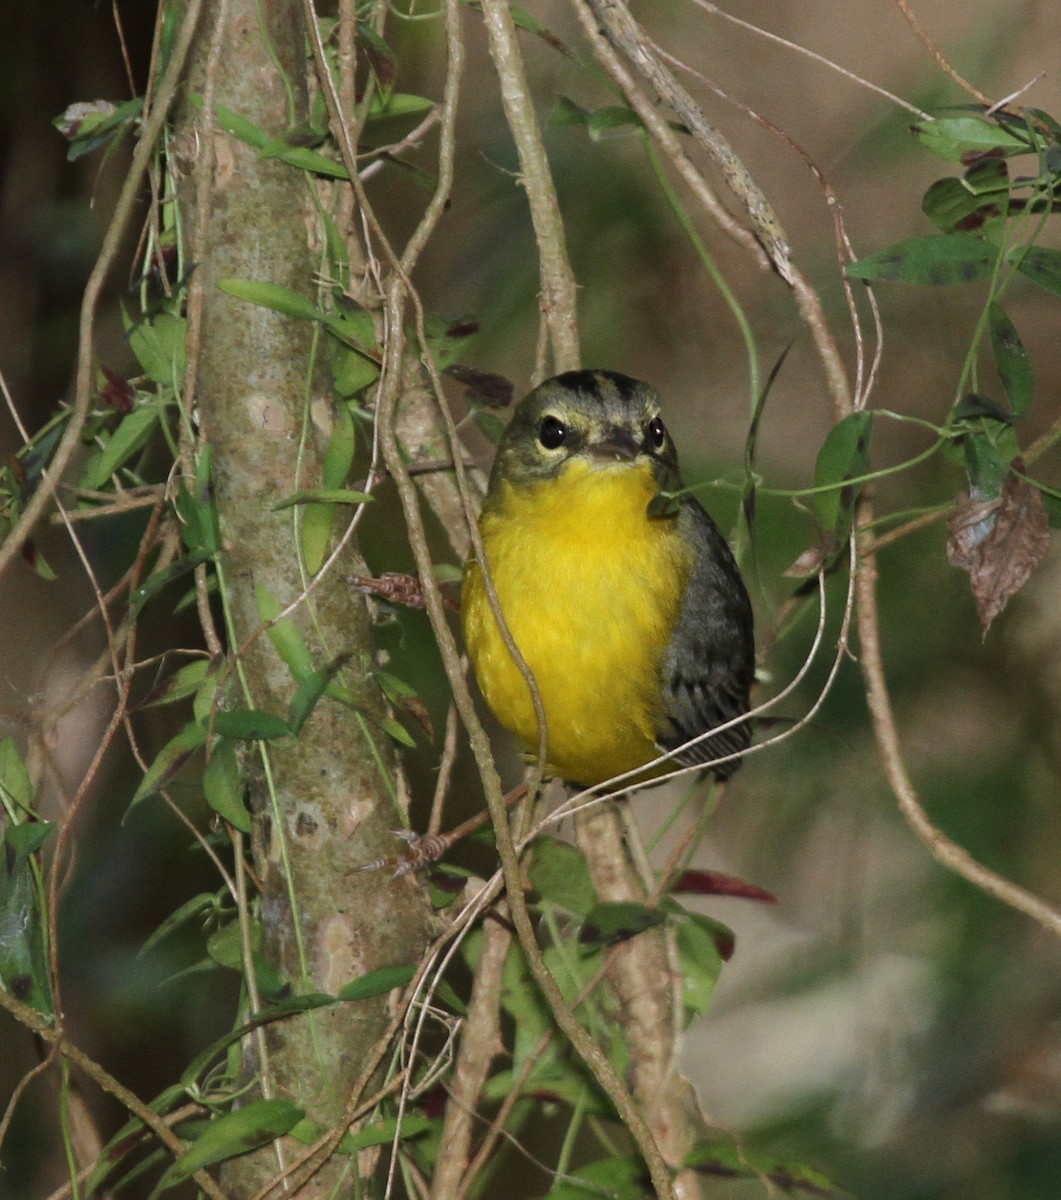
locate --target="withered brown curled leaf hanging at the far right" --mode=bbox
[947,472,1050,635]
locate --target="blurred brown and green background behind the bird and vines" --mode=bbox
[0,0,1061,1200]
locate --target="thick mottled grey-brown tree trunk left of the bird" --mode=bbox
[170,0,430,1198]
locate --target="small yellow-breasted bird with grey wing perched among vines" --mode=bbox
[461,371,755,786]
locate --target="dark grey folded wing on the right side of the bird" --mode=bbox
[659,496,755,779]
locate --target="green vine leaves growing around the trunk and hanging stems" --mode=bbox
[10,5,1061,1200]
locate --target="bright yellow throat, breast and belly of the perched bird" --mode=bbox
[461,461,691,784]
